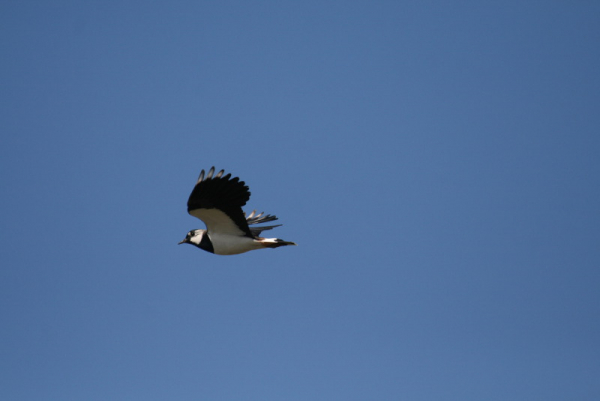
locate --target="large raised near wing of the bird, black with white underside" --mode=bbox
[188,167,254,238]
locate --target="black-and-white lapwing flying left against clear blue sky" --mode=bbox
[179,166,296,255]
